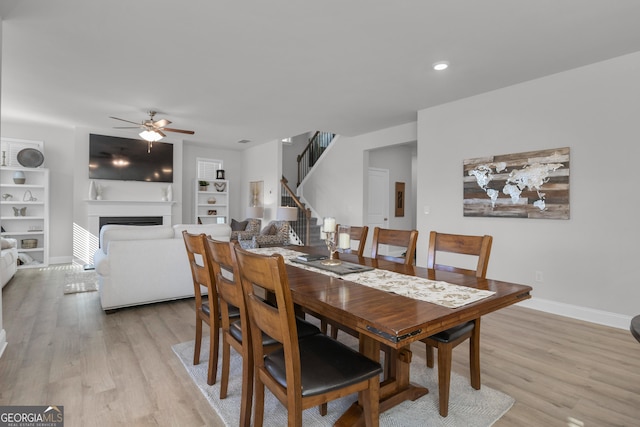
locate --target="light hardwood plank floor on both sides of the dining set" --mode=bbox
[0,266,640,427]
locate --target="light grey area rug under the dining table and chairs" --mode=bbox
[172,337,514,427]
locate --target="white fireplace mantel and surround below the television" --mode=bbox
[85,200,175,236]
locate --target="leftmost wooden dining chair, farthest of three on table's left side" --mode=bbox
[182,230,240,385]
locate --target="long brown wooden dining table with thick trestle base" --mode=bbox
[252,246,532,426]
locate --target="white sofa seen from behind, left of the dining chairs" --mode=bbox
[93,224,231,311]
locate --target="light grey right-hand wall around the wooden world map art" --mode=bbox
[417,53,640,327]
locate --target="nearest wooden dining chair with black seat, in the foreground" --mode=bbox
[235,246,382,427]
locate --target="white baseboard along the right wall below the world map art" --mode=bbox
[518,297,632,329]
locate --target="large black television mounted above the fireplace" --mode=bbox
[89,134,173,182]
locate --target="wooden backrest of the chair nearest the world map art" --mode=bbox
[427,231,493,278]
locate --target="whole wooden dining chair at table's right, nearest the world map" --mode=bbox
[422,231,493,417]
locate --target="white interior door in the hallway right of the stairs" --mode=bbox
[365,168,389,254]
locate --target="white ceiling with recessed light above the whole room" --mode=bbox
[0,0,640,149]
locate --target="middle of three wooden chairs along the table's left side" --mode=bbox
[206,237,320,426]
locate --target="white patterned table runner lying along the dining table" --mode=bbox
[246,247,495,308]
